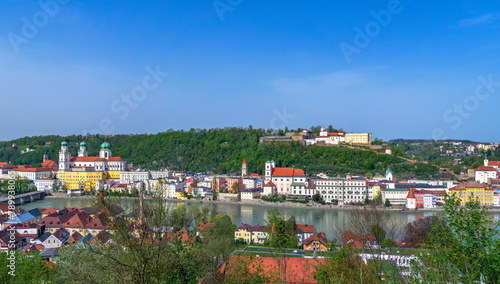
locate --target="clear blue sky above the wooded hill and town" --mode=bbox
[0,0,500,142]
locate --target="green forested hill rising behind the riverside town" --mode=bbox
[0,128,437,178]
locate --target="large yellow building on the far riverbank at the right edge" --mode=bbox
[450,181,494,206]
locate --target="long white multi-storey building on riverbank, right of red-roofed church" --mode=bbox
[316,179,368,205]
